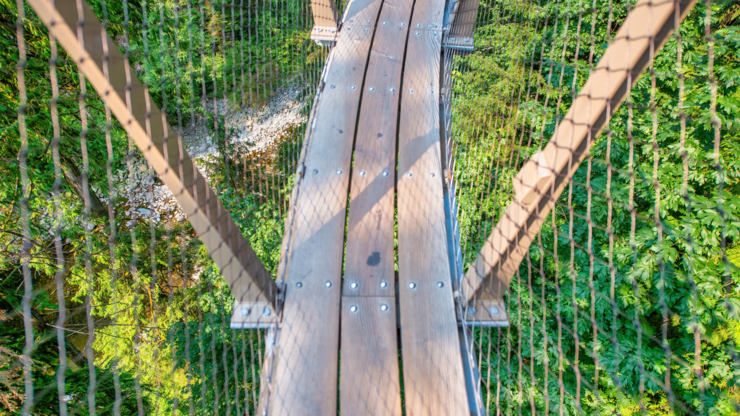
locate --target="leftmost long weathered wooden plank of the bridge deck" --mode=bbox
[266,0,382,415]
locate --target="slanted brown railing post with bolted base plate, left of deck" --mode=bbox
[28,0,278,327]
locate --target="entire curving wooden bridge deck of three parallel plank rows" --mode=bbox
[260,0,482,416]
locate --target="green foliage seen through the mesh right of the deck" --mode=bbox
[453,1,740,414]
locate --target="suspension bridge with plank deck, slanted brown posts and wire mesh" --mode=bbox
[5,0,736,416]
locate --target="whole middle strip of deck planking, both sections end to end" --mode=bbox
[339,0,414,416]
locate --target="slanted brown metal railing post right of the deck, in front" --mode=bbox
[462,0,696,304]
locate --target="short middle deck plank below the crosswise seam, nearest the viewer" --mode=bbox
[340,296,401,416]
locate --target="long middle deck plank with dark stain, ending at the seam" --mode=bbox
[343,0,413,296]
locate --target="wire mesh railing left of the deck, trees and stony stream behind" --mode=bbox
[0,0,327,415]
